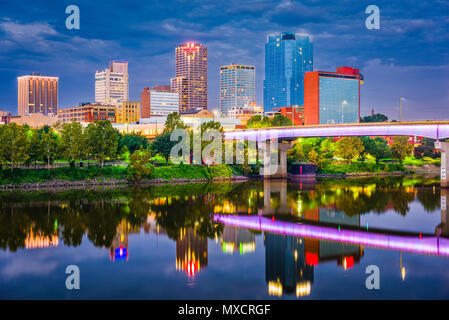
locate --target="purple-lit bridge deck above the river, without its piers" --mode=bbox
[225,121,449,141]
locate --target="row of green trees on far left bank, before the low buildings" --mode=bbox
[0,121,149,171]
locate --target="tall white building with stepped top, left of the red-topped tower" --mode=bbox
[95,61,129,104]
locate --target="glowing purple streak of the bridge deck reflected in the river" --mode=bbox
[214,214,449,256]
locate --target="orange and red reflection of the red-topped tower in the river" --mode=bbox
[176,228,208,277]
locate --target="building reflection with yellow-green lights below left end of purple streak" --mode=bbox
[221,226,256,255]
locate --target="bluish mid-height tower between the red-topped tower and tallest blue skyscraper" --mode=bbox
[220,64,256,115]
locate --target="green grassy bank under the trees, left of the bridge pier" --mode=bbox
[0,164,232,185]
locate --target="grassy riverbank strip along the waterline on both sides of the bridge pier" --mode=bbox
[0,164,440,190]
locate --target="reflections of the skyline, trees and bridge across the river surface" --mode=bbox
[0,178,449,298]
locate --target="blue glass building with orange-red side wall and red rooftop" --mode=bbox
[304,67,363,125]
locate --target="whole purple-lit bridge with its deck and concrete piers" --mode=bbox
[224,121,449,187]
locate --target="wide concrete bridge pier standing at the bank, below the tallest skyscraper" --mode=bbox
[262,140,292,179]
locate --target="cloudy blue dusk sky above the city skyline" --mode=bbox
[0,0,449,120]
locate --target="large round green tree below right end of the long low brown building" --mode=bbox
[86,120,118,168]
